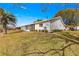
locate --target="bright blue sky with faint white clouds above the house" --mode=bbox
[0,3,78,26]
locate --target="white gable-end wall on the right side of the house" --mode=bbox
[51,19,65,30]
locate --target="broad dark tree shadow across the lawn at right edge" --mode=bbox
[52,32,79,44]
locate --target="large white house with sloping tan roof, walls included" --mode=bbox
[35,16,65,32]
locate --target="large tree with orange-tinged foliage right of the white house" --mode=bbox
[55,9,79,25]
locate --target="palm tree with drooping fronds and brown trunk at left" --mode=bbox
[0,8,16,34]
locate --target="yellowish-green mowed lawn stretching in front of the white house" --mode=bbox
[0,31,79,56]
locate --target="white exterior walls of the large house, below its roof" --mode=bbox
[35,18,65,32]
